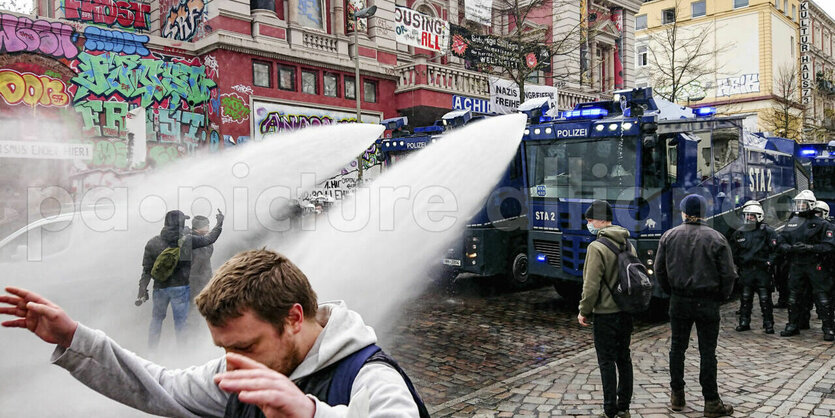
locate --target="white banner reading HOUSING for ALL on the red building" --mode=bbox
[394,6,449,54]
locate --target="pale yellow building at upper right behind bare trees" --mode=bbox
[635,0,804,138]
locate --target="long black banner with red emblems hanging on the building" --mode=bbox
[450,25,551,72]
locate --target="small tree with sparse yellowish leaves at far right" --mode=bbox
[762,65,803,141]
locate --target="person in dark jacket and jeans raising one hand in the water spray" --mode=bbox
[138,210,223,349]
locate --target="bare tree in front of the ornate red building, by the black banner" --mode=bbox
[461,0,594,101]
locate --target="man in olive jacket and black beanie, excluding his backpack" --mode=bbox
[577,200,635,418]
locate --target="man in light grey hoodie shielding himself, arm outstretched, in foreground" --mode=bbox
[0,249,428,418]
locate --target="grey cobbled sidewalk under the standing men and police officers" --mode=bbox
[430,302,835,418]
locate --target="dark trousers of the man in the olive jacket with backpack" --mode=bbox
[593,312,632,417]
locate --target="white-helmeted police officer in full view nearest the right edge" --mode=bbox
[779,190,835,341]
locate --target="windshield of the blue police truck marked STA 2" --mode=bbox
[527,137,637,200]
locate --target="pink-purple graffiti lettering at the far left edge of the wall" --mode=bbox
[0,14,78,59]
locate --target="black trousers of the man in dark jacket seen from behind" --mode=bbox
[670,295,719,401]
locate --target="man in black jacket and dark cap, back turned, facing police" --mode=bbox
[655,194,737,417]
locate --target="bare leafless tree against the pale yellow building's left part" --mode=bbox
[646,0,727,102]
